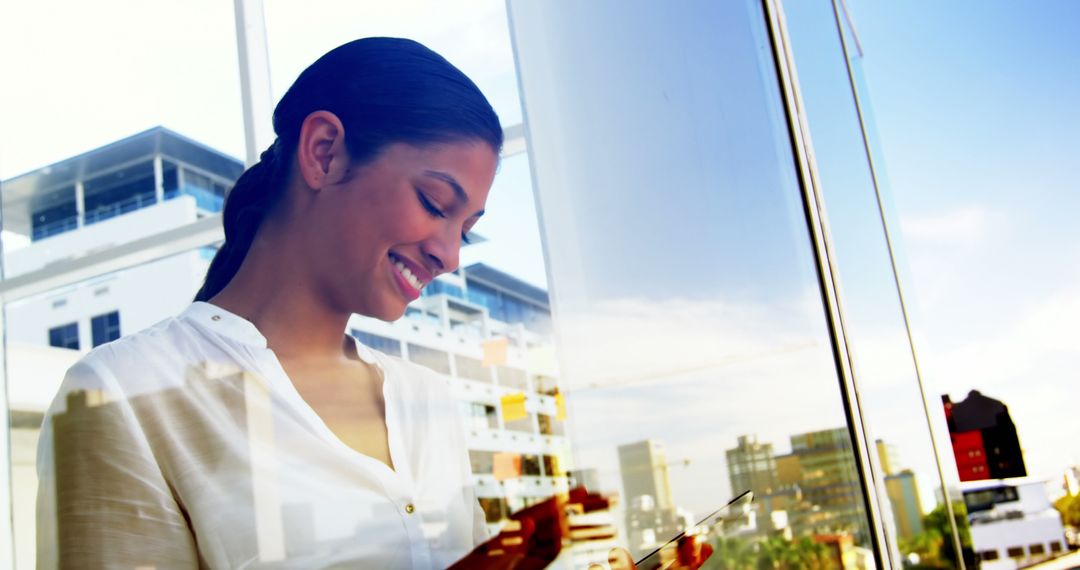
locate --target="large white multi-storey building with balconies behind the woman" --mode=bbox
[3,127,569,568]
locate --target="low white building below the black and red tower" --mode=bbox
[961,477,1066,570]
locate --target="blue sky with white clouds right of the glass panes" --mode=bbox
[849,0,1080,485]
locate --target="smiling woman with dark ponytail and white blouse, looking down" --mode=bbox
[38,38,544,568]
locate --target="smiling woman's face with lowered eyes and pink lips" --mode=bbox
[309,143,498,321]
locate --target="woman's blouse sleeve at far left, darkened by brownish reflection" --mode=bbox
[37,359,199,568]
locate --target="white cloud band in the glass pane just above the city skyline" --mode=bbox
[557,296,846,512]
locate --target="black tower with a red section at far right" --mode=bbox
[942,390,1027,481]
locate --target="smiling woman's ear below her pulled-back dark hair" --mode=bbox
[296,111,349,190]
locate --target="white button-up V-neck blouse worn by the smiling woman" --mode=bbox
[38,302,487,569]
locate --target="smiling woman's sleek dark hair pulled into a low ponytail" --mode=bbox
[194,38,502,301]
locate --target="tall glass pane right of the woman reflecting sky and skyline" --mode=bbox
[510,1,873,567]
